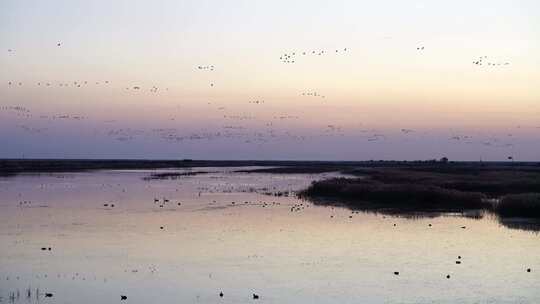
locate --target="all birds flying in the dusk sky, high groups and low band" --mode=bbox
[0,42,524,153]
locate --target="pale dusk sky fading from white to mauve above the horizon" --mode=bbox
[0,0,540,161]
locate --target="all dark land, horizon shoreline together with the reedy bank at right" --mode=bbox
[0,159,540,218]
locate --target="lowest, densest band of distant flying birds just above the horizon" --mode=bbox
[5,100,515,148]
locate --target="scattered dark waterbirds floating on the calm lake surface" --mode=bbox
[0,166,532,303]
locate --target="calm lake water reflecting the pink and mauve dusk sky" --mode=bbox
[0,168,540,303]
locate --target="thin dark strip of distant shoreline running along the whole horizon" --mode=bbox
[0,159,540,175]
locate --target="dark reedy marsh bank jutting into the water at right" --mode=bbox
[299,166,540,218]
